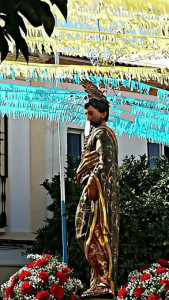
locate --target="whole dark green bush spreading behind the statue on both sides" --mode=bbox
[31,155,169,286]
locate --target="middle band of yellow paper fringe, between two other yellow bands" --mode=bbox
[5,25,166,63]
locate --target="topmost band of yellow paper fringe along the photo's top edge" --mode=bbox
[42,0,169,35]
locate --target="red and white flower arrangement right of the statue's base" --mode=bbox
[117,258,169,300]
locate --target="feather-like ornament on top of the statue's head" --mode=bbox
[81,79,109,105]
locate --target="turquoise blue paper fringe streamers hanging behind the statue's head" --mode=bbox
[0,79,169,145]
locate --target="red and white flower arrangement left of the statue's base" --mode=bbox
[1,254,83,300]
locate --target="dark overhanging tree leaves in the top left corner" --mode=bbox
[0,0,67,62]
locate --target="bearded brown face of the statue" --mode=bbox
[85,105,107,127]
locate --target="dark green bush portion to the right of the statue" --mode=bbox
[118,156,169,284]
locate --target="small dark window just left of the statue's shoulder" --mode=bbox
[67,129,84,157]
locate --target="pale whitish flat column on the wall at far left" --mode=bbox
[9,118,30,232]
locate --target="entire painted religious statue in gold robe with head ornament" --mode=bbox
[75,80,119,298]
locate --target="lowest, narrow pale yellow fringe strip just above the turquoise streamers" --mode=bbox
[0,61,169,85]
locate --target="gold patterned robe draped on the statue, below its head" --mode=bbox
[75,125,119,293]
